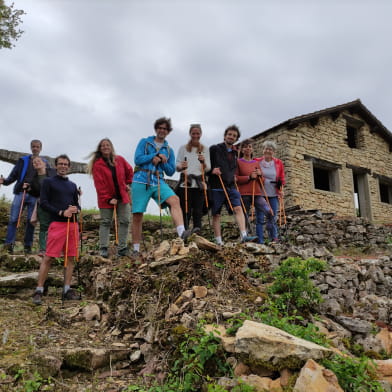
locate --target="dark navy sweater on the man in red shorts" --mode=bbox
[40,175,80,222]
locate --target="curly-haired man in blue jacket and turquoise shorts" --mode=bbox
[132,117,190,255]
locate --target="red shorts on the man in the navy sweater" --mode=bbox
[45,222,79,257]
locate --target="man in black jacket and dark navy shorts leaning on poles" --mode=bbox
[210,125,257,245]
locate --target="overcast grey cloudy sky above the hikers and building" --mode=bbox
[0,0,392,213]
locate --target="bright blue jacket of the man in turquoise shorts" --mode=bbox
[133,136,176,186]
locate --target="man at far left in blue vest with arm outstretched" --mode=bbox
[0,140,42,254]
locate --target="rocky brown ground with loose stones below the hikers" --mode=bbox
[0,207,392,392]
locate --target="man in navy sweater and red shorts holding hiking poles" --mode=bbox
[33,154,80,305]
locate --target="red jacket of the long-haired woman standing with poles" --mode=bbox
[92,155,133,208]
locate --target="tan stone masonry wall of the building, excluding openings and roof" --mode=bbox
[255,112,392,222]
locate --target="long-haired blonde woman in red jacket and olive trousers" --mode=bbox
[88,138,133,257]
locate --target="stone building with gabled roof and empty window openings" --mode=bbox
[253,99,392,223]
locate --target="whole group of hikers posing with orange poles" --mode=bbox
[0,117,285,305]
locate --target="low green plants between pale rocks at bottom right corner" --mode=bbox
[322,355,384,392]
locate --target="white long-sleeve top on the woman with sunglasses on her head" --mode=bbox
[176,145,211,188]
